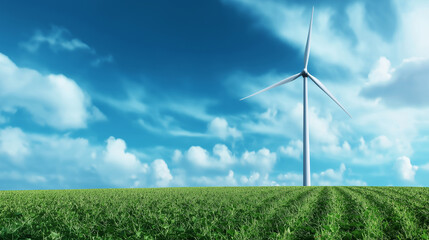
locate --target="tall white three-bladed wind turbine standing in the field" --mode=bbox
[240,7,352,186]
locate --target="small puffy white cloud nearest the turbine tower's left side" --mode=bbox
[241,148,277,173]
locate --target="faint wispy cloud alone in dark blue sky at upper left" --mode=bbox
[21,26,93,52]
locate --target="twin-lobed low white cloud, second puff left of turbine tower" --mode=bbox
[186,144,236,169]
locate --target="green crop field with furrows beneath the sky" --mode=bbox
[0,187,429,239]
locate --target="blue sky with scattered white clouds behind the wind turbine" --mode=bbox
[0,0,429,190]
